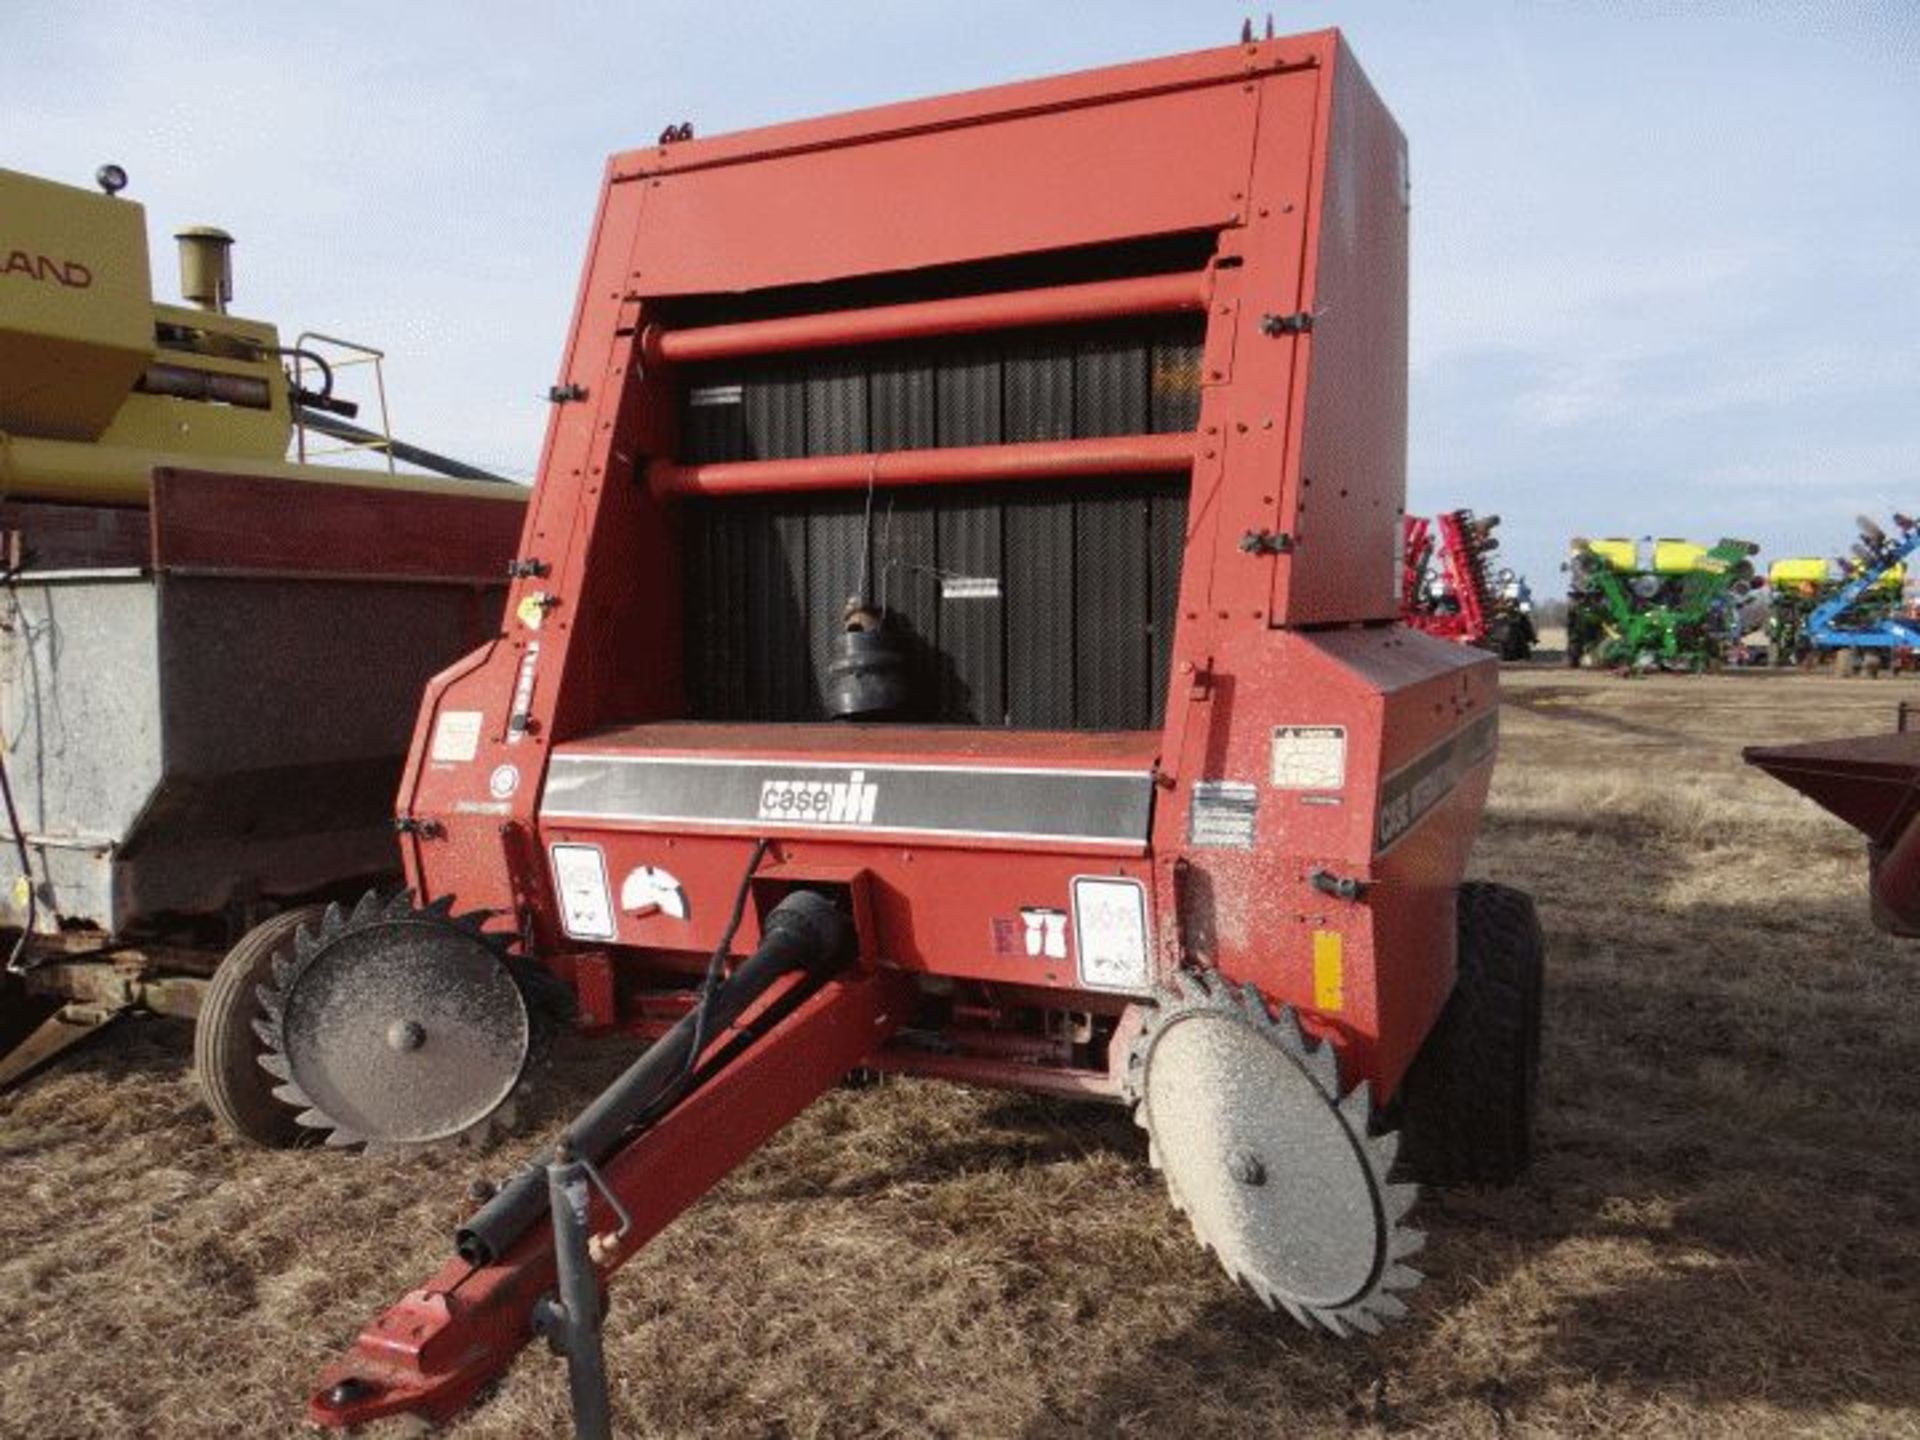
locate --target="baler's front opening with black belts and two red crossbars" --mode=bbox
[659,247,1212,730]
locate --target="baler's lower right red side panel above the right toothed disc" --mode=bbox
[1154,628,1498,1092]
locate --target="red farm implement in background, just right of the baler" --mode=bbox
[1400,511,1538,660]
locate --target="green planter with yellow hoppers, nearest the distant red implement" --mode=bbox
[1567,538,1764,674]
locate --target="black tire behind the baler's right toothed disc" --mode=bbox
[1394,881,1546,1187]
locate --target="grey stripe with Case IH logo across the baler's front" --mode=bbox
[540,753,1154,851]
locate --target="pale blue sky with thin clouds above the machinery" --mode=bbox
[0,0,1920,589]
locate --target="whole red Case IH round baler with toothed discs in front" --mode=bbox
[280,33,1542,1427]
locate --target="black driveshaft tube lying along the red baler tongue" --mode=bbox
[453,891,854,1265]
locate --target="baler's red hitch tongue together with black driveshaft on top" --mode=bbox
[307,891,912,1427]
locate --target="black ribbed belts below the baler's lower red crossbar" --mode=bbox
[682,476,1187,730]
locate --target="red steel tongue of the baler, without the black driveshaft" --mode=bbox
[307,972,912,1427]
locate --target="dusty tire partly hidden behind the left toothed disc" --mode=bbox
[194,904,324,1150]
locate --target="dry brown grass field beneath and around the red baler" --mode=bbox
[0,668,1920,1440]
